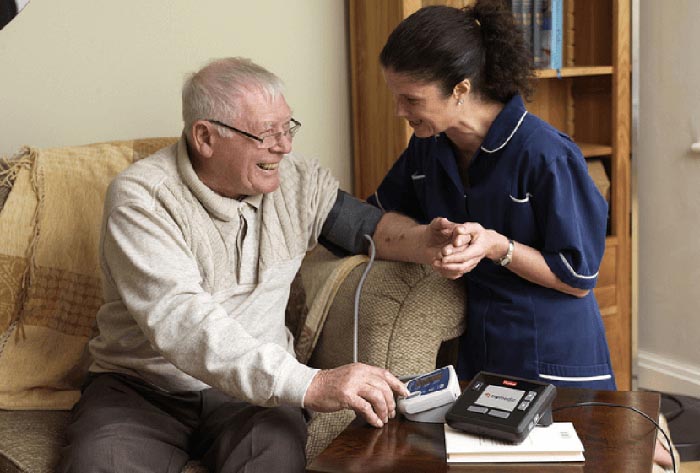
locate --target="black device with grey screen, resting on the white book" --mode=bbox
[445,371,556,443]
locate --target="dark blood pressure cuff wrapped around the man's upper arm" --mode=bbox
[321,190,384,254]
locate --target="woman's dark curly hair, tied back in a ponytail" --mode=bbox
[379,0,533,103]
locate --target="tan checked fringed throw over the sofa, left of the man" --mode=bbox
[0,138,175,409]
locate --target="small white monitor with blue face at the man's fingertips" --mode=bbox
[396,365,461,423]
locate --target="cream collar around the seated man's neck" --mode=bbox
[176,135,263,222]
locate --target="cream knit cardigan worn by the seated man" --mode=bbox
[90,139,338,406]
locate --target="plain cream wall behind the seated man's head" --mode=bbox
[0,0,352,190]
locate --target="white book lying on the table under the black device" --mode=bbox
[445,422,585,463]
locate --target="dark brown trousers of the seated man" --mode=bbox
[56,373,307,473]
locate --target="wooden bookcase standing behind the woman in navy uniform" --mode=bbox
[349,0,631,390]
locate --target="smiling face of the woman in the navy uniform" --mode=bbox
[383,69,457,138]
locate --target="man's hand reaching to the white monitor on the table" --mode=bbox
[304,363,408,427]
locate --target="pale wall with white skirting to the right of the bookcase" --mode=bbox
[633,0,700,397]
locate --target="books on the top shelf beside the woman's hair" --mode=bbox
[510,0,564,70]
